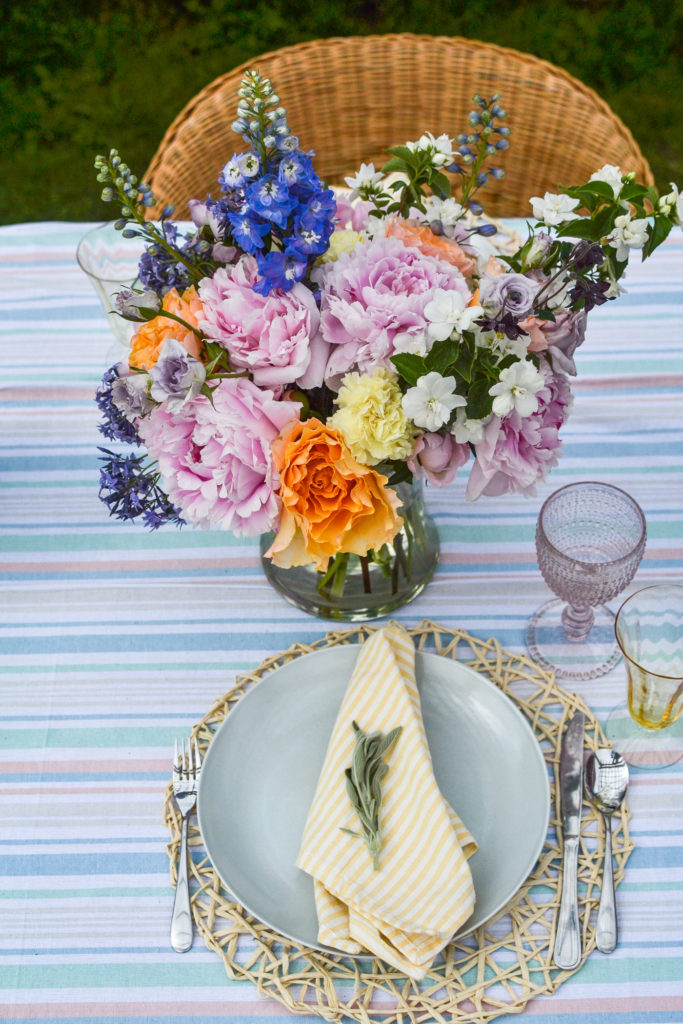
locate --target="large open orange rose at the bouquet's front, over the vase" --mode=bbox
[266,419,401,571]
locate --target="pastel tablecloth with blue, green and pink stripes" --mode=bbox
[0,223,683,1024]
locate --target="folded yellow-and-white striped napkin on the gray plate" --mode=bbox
[297,623,476,980]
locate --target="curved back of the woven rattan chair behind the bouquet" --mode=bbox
[144,35,652,217]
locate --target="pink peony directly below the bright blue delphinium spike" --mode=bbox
[199,256,329,388]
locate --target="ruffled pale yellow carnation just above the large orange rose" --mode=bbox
[328,367,418,466]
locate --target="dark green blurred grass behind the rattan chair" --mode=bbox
[0,0,683,224]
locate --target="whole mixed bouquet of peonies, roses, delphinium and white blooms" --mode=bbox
[95,72,683,610]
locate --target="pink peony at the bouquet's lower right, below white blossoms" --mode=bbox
[466,362,571,501]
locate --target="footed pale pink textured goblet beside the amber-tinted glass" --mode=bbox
[526,481,647,679]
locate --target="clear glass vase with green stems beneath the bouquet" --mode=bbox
[261,480,439,623]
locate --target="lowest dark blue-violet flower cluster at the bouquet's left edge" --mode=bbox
[99,447,184,529]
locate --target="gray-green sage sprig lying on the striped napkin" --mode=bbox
[342,722,403,871]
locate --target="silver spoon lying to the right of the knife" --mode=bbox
[584,748,629,953]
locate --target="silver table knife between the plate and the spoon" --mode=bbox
[553,711,586,971]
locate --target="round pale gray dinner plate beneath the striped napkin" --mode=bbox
[198,644,550,951]
